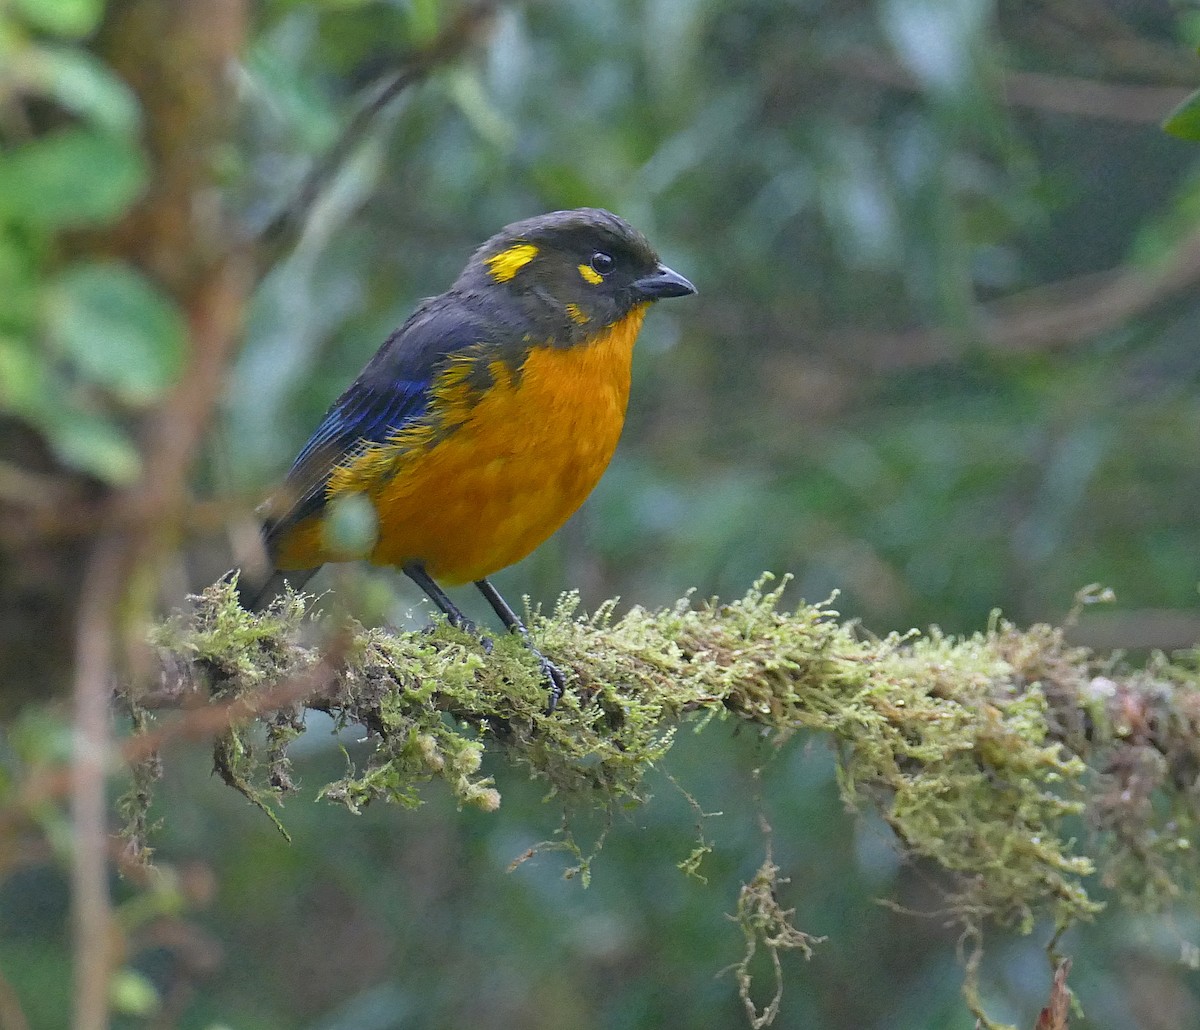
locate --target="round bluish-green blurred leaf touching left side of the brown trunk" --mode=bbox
[47,263,187,405]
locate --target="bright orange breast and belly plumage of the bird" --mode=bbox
[278,306,646,585]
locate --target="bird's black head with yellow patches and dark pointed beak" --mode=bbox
[455,208,696,343]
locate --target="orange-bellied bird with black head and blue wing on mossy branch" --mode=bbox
[240,208,696,712]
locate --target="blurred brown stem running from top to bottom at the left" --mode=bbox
[68,0,250,1030]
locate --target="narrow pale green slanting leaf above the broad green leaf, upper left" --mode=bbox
[12,47,142,136]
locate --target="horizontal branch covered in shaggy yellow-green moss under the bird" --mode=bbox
[136,573,1200,1022]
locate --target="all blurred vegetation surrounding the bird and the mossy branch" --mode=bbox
[0,0,1200,1030]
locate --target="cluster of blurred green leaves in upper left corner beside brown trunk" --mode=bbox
[0,0,184,484]
